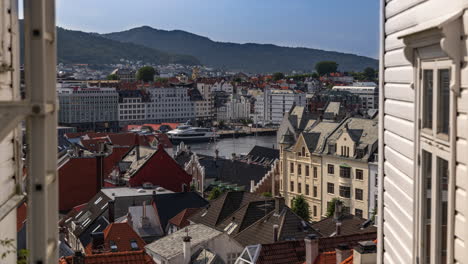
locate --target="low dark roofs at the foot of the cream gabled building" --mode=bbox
[312,214,377,237]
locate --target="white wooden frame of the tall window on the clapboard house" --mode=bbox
[415,57,456,264]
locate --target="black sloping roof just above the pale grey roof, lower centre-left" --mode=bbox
[153,192,208,229]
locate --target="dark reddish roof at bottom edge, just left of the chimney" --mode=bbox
[256,240,305,264]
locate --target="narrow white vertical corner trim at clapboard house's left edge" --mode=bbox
[377,0,386,264]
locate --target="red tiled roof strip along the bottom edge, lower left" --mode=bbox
[59,250,154,264]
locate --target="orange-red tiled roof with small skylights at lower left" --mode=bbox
[85,223,145,255]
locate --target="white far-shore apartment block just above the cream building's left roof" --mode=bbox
[254,89,306,124]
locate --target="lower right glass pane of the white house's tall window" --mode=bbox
[437,158,449,264]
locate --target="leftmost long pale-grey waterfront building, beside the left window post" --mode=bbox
[57,87,119,129]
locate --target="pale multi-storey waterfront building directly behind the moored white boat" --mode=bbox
[146,87,195,123]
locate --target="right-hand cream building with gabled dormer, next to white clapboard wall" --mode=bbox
[321,118,378,219]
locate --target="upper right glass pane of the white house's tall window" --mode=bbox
[437,69,450,135]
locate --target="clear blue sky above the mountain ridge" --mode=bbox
[25,0,380,58]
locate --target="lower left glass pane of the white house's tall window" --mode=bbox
[422,150,432,263]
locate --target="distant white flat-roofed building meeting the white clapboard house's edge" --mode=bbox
[332,82,379,109]
